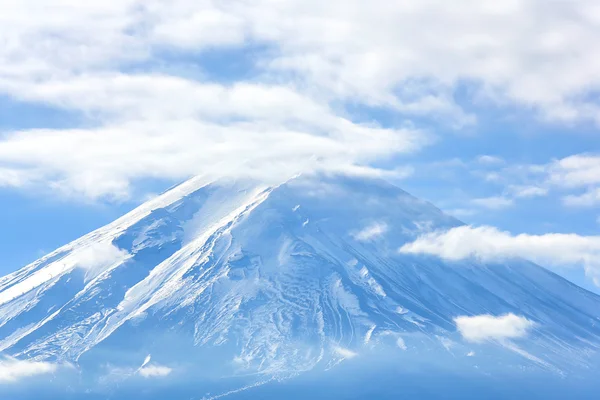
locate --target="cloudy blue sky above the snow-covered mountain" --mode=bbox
[0,0,600,291]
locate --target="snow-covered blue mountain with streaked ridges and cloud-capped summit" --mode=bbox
[0,176,600,399]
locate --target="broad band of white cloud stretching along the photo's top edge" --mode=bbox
[0,0,599,126]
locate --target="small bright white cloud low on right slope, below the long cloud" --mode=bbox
[454,313,535,343]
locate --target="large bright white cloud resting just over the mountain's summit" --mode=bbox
[0,76,431,199]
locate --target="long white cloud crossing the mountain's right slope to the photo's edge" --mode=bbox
[400,225,600,284]
